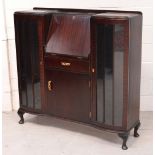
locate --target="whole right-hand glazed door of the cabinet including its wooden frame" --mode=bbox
[92,20,128,129]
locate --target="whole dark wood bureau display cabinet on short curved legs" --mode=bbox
[14,8,142,150]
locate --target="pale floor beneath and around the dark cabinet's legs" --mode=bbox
[2,112,153,155]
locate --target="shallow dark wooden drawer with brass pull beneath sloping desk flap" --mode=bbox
[45,55,89,74]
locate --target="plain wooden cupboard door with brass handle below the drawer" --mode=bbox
[46,70,90,122]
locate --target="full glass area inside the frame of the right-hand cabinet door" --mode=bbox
[96,24,124,126]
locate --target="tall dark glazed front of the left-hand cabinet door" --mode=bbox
[15,16,41,110]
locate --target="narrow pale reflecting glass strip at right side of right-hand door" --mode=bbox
[113,24,124,126]
